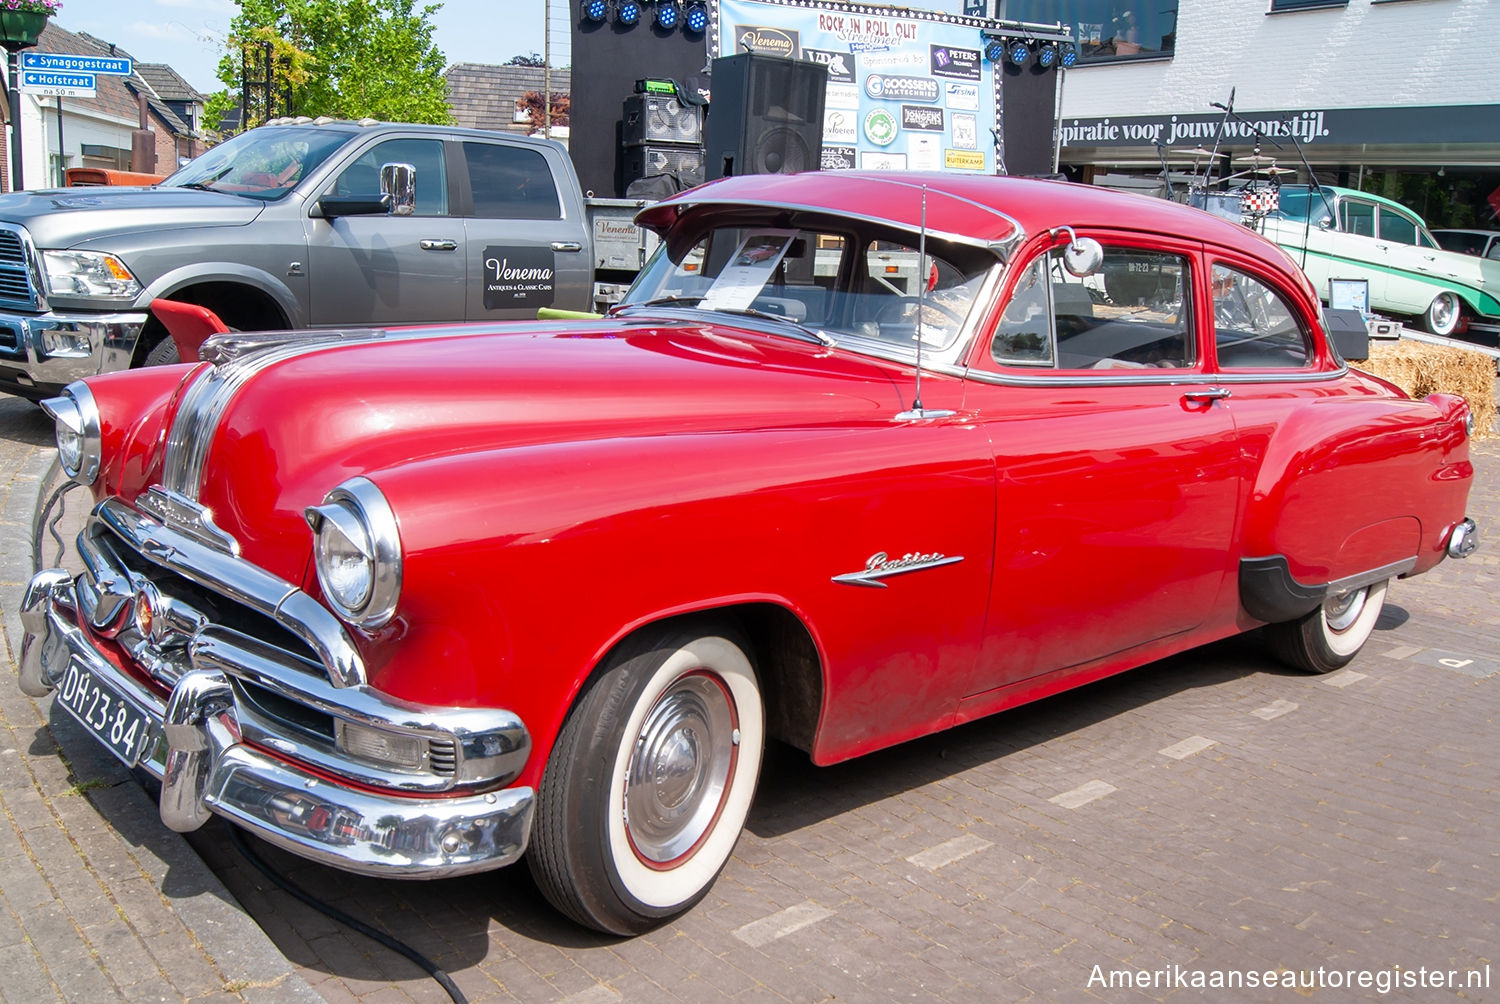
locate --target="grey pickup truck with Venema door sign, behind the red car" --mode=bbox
[0,120,596,399]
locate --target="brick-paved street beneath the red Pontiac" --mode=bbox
[0,387,1500,1002]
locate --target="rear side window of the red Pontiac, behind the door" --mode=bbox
[1212,264,1313,369]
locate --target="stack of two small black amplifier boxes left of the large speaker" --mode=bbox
[621,93,704,198]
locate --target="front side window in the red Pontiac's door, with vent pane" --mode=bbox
[990,248,1197,369]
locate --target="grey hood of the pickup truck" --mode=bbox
[0,186,264,248]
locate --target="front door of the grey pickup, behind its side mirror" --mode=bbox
[308,135,467,326]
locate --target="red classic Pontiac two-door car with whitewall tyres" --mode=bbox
[21,173,1476,933]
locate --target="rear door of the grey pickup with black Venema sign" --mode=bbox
[462,140,593,321]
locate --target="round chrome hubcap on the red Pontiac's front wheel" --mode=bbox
[626,672,738,864]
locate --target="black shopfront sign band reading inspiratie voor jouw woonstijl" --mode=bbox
[1059,105,1500,147]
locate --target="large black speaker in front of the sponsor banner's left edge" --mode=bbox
[704,53,828,180]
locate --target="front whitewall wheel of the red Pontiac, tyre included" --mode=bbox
[527,624,765,935]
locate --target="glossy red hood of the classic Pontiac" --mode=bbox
[170,313,911,582]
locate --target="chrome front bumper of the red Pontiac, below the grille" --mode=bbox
[20,569,536,878]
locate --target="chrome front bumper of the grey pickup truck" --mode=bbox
[0,311,147,396]
